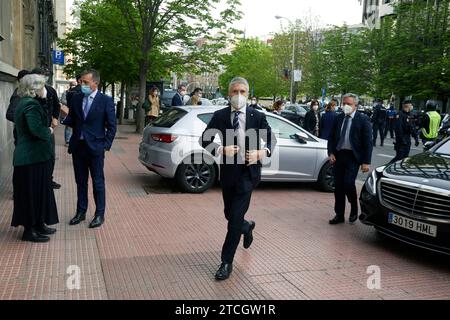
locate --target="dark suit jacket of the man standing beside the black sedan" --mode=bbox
[328,112,373,165]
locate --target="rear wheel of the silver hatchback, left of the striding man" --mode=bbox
[176,156,217,193]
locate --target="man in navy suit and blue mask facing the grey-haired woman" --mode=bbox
[63,70,116,228]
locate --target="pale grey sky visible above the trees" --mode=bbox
[239,0,362,37]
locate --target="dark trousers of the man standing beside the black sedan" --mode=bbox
[334,150,359,218]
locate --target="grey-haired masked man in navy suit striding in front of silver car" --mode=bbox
[199,78,276,280]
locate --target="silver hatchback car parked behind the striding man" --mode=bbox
[139,106,334,193]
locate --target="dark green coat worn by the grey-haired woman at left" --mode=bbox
[13,97,52,167]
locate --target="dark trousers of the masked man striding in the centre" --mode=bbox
[222,165,253,263]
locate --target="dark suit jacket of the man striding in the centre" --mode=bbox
[199,106,276,187]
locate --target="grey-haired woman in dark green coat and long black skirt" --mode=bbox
[11,74,59,242]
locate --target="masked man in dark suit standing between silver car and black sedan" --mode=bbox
[328,93,373,224]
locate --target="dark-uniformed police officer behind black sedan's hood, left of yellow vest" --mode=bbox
[389,100,419,164]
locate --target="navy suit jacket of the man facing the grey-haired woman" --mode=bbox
[63,91,117,155]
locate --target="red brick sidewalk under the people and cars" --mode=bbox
[0,126,450,299]
